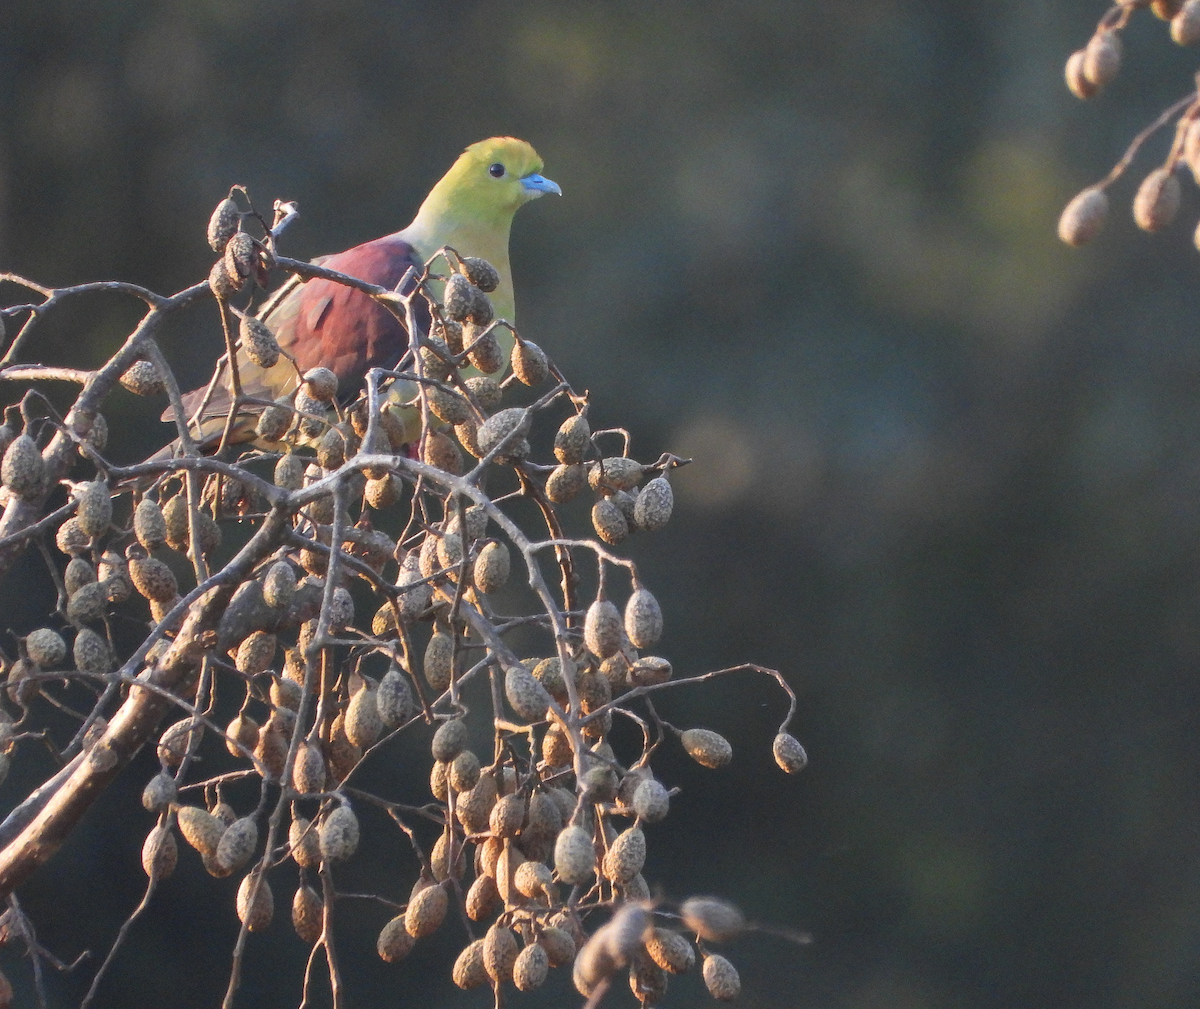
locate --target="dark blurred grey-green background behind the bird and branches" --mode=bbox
[0,0,1200,1009]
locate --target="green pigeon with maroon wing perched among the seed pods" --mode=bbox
[171,137,562,440]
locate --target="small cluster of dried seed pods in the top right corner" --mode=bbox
[1058,0,1200,248]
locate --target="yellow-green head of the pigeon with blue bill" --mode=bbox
[419,137,562,229]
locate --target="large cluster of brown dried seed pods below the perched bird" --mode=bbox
[0,198,808,1004]
